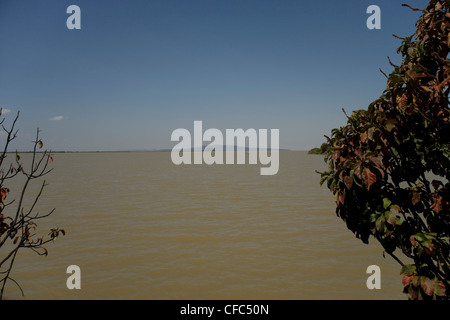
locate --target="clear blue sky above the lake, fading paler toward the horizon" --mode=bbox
[0,0,428,151]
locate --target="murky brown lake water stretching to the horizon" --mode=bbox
[5,151,406,300]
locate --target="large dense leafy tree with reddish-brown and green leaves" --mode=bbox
[321,0,450,299]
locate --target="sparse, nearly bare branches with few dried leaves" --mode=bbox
[0,109,65,299]
